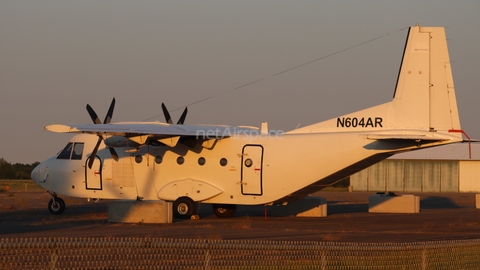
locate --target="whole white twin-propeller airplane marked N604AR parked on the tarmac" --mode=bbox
[32,25,463,218]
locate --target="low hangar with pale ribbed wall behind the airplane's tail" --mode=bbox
[350,143,480,192]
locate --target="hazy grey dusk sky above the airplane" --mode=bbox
[0,0,480,164]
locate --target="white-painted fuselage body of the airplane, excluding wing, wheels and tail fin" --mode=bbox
[32,132,444,205]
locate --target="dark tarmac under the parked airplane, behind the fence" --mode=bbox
[0,191,480,243]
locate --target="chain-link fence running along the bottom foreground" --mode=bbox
[0,238,480,269]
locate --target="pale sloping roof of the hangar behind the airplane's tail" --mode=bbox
[388,142,480,160]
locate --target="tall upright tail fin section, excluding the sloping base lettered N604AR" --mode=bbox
[392,25,460,131]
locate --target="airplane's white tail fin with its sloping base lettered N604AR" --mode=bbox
[288,25,461,139]
